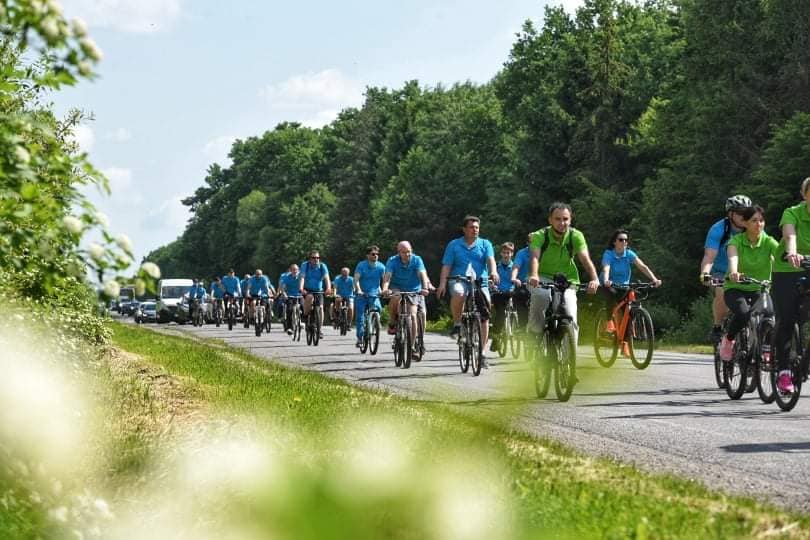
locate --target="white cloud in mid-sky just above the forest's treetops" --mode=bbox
[259,69,363,110]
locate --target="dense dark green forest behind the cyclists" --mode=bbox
[147,0,810,324]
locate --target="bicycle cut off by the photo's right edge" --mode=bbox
[771,255,810,411]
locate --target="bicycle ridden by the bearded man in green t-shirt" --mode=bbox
[532,274,588,402]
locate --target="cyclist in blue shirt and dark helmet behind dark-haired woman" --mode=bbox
[700,195,751,341]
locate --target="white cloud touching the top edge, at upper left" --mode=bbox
[63,0,182,33]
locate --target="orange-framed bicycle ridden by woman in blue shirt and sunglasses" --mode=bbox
[593,282,655,369]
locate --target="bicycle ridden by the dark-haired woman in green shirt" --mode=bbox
[723,277,776,403]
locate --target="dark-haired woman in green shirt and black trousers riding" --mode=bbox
[718,206,789,362]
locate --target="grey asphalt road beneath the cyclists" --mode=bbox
[130,319,810,512]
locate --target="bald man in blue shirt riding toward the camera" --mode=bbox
[380,240,431,336]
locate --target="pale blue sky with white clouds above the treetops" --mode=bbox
[52,0,582,268]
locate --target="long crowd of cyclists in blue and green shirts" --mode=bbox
[172,178,810,408]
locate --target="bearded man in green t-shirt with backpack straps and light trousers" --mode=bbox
[528,202,599,346]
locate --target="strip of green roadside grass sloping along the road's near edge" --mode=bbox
[107,325,810,538]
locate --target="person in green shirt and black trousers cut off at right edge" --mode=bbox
[771,177,810,393]
